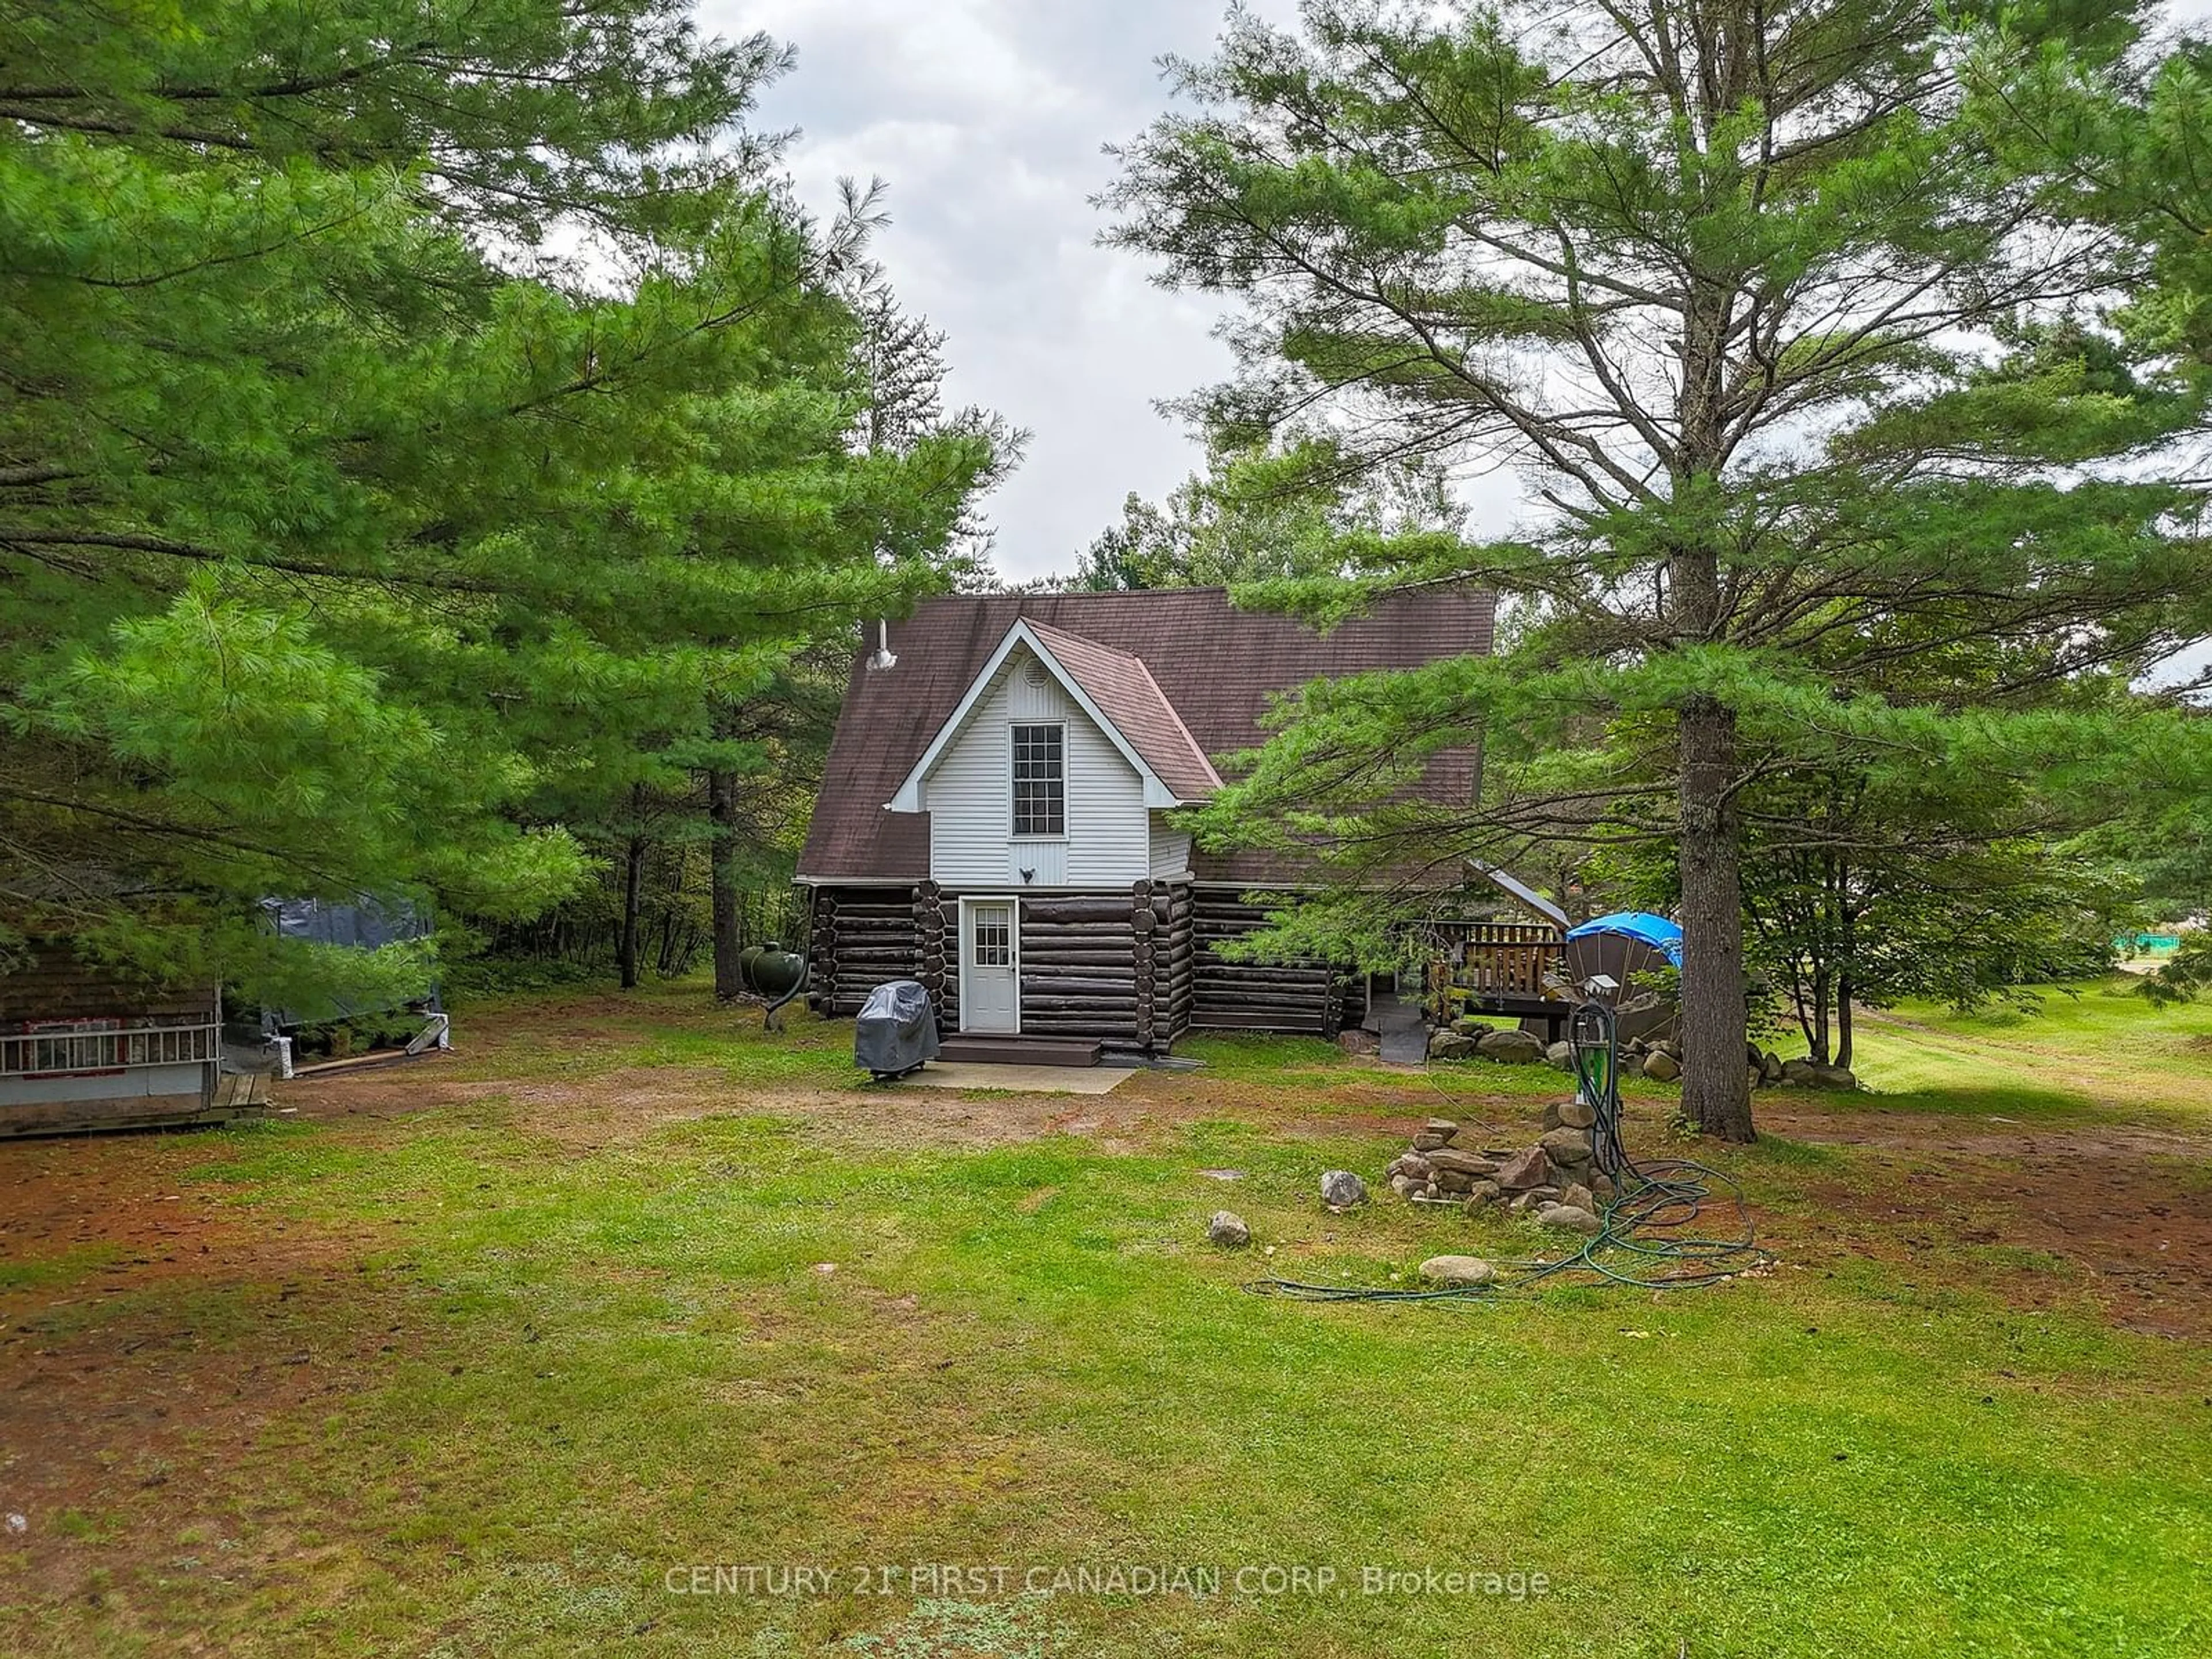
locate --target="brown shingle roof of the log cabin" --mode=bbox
[798,588,1495,885]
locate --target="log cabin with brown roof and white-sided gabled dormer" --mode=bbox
[798,588,1495,1064]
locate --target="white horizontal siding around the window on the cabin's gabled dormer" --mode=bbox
[922,650,1150,889]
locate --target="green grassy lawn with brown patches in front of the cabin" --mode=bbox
[0,987,2212,1659]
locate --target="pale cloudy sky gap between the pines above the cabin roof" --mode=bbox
[699,0,1294,577]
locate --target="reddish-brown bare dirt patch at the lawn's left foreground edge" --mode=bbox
[0,1132,409,1635]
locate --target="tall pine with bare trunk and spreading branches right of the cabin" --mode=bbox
[1108,0,2212,1139]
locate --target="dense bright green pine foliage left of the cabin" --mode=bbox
[0,0,998,999]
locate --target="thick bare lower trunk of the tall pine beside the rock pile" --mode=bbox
[1679,697,1754,1141]
